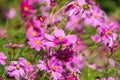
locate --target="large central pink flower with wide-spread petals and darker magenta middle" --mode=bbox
[45,29,77,47]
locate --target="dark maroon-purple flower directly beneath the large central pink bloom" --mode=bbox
[55,48,74,62]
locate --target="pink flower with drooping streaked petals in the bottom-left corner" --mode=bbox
[6,61,26,80]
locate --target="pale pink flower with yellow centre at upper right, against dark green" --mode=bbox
[85,5,105,27]
